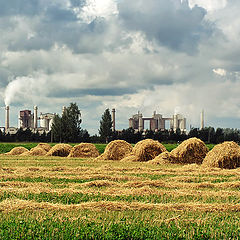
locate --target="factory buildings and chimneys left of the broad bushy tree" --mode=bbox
[2,106,55,134]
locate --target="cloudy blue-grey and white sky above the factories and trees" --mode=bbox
[0,0,240,134]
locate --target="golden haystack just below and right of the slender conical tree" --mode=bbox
[96,140,133,160]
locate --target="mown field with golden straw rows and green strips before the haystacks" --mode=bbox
[0,145,240,239]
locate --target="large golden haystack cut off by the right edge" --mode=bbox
[203,142,240,169]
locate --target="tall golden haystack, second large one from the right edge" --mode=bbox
[171,138,209,164]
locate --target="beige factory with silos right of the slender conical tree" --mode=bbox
[129,111,186,132]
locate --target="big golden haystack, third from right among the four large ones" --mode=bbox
[122,139,167,162]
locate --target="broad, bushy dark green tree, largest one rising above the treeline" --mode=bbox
[52,103,82,142]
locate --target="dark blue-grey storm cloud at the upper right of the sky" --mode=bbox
[118,0,212,53]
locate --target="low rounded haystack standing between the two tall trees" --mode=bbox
[68,143,99,158]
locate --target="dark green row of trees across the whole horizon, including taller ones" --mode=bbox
[0,103,240,144]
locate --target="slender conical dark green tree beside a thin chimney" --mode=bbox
[98,109,113,143]
